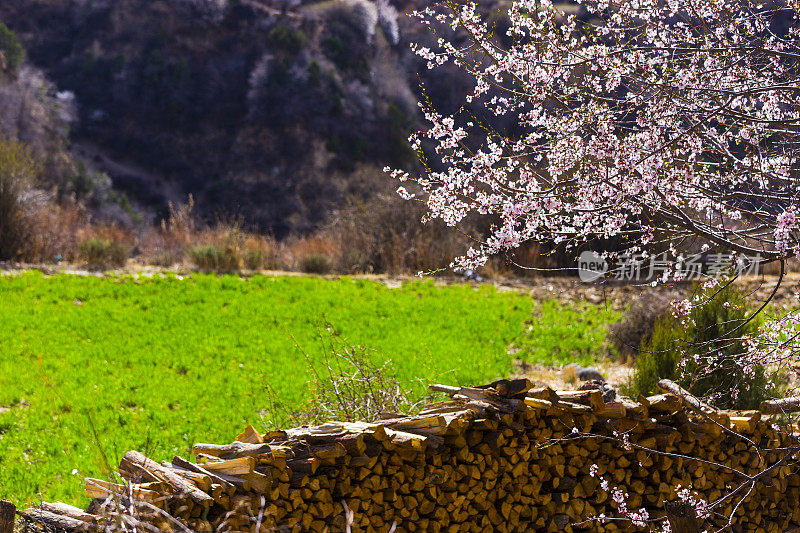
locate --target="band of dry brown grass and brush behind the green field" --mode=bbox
[6,189,592,277]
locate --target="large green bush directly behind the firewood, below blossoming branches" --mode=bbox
[626,287,778,409]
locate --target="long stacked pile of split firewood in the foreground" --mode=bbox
[17,380,800,533]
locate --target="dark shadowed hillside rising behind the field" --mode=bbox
[0,0,476,237]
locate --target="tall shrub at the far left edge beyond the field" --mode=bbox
[0,141,38,260]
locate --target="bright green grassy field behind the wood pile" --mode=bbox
[0,272,620,505]
